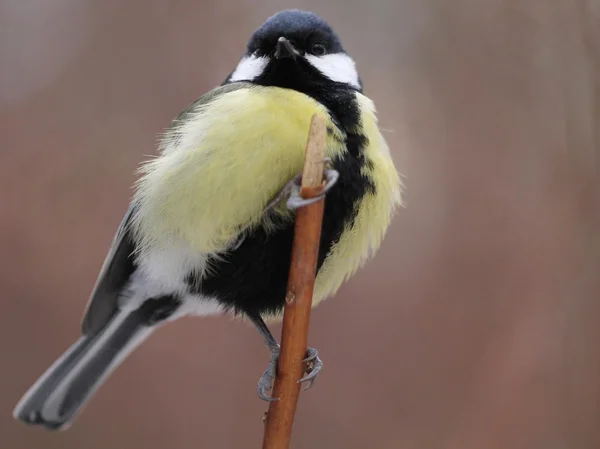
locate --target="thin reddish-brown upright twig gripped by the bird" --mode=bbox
[262,114,327,449]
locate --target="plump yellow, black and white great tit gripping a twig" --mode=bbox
[13,9,403,430]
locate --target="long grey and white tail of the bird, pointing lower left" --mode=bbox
[13,307,155,430]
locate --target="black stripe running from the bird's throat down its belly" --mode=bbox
[197,61,375,315]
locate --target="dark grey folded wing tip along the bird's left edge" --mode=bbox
[81,204,135,335]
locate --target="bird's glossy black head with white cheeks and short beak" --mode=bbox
[227,9,362,92]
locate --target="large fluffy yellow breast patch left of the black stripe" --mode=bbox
[132,85,345,253]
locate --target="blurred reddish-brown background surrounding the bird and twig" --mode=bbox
[0,0,600,449]
